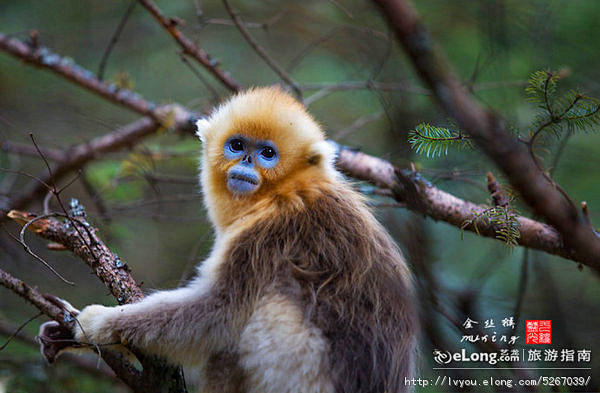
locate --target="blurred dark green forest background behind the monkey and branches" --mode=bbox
[0,0,600,392]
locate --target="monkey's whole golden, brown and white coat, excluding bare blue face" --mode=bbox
[61,88,417,393]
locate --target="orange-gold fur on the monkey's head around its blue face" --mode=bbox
[198,87,335,230]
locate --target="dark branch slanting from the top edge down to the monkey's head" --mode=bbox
[139,0,242,91]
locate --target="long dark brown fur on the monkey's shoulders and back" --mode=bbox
[219,182,417,393]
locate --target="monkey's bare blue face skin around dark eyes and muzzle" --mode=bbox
[223,135,279,195]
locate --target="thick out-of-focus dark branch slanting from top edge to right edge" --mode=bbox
[375,0,600,270]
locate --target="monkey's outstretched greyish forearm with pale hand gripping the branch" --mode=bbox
[74,287,228,362]
